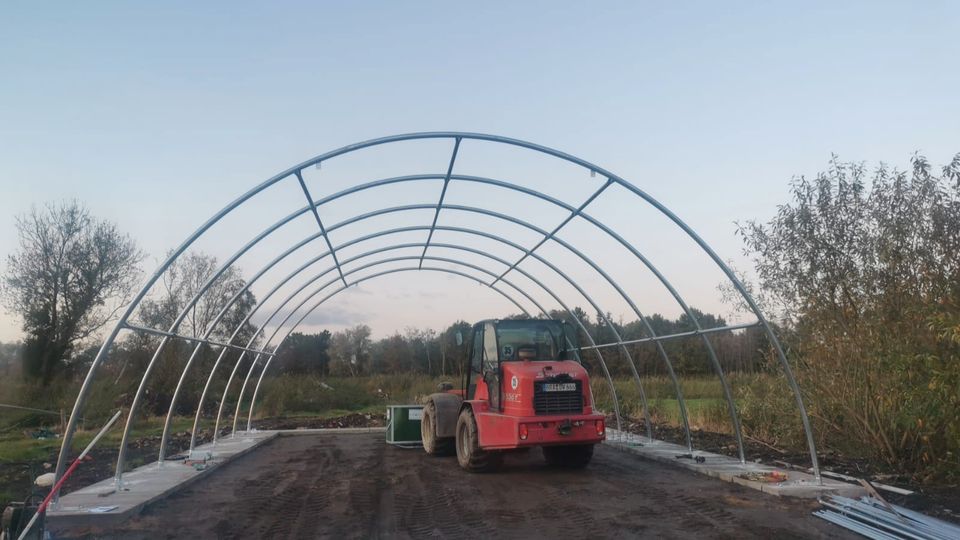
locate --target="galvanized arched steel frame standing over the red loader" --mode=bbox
[50,132,820,502]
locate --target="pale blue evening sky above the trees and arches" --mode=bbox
[0,1,960,341]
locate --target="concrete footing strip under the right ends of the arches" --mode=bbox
[604,428,866,499]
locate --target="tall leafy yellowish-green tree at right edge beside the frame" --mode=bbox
[740,154,960,474]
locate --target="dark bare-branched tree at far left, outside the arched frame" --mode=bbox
[2,201,143,385]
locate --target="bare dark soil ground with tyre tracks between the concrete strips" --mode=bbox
[56,433,852,538]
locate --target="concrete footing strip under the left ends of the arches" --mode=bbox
[47,431,278,528]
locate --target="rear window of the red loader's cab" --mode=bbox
[497,319,580,362]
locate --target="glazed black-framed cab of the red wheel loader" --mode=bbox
[464,319,580,410]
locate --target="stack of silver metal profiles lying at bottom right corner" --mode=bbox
[813,495,960,540]
